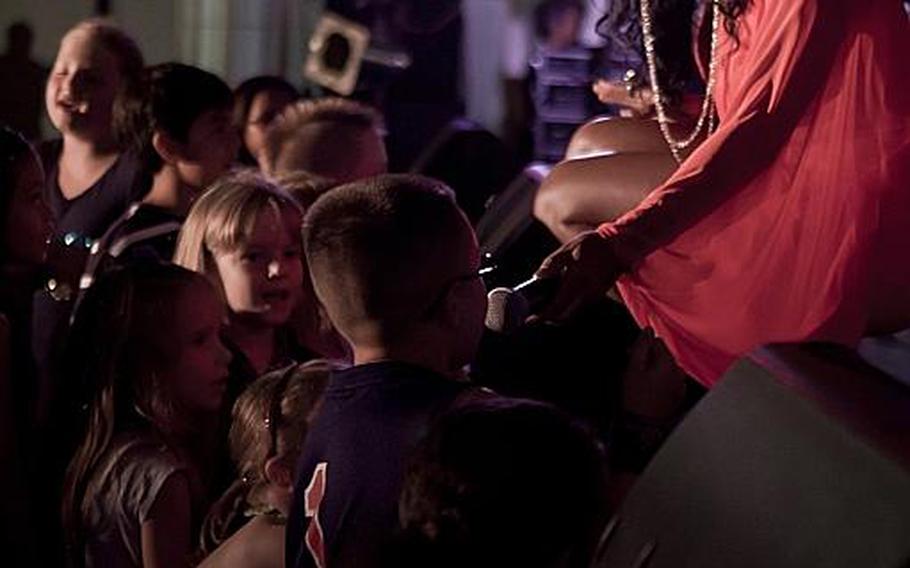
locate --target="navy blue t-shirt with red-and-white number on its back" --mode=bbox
[285,361,471,568]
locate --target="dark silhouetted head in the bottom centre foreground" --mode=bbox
[396,399,606,568]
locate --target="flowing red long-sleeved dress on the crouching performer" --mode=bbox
[599,0,910,386]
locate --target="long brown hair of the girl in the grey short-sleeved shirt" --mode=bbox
[61,264,208,566]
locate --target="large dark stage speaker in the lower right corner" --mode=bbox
[594,345,910,568]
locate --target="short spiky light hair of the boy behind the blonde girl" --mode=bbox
[260,97,383,179]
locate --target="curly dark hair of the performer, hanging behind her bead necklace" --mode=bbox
[597,0,752,101]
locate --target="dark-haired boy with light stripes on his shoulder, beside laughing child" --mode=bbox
[80,63,239,289]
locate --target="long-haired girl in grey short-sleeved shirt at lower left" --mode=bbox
[63,265,230,568]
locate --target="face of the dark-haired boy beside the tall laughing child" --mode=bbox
[177,108,240,189]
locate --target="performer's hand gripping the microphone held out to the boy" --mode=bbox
[535,231,623,321]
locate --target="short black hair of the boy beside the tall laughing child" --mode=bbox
[121,63,233,174]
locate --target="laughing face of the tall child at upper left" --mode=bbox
[45,29,120,139]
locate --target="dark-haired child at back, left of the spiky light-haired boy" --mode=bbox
[234,75,300,166]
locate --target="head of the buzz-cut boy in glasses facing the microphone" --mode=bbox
[303,174,472,339]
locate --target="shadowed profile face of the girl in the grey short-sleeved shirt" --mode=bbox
[168,282,231,412]
